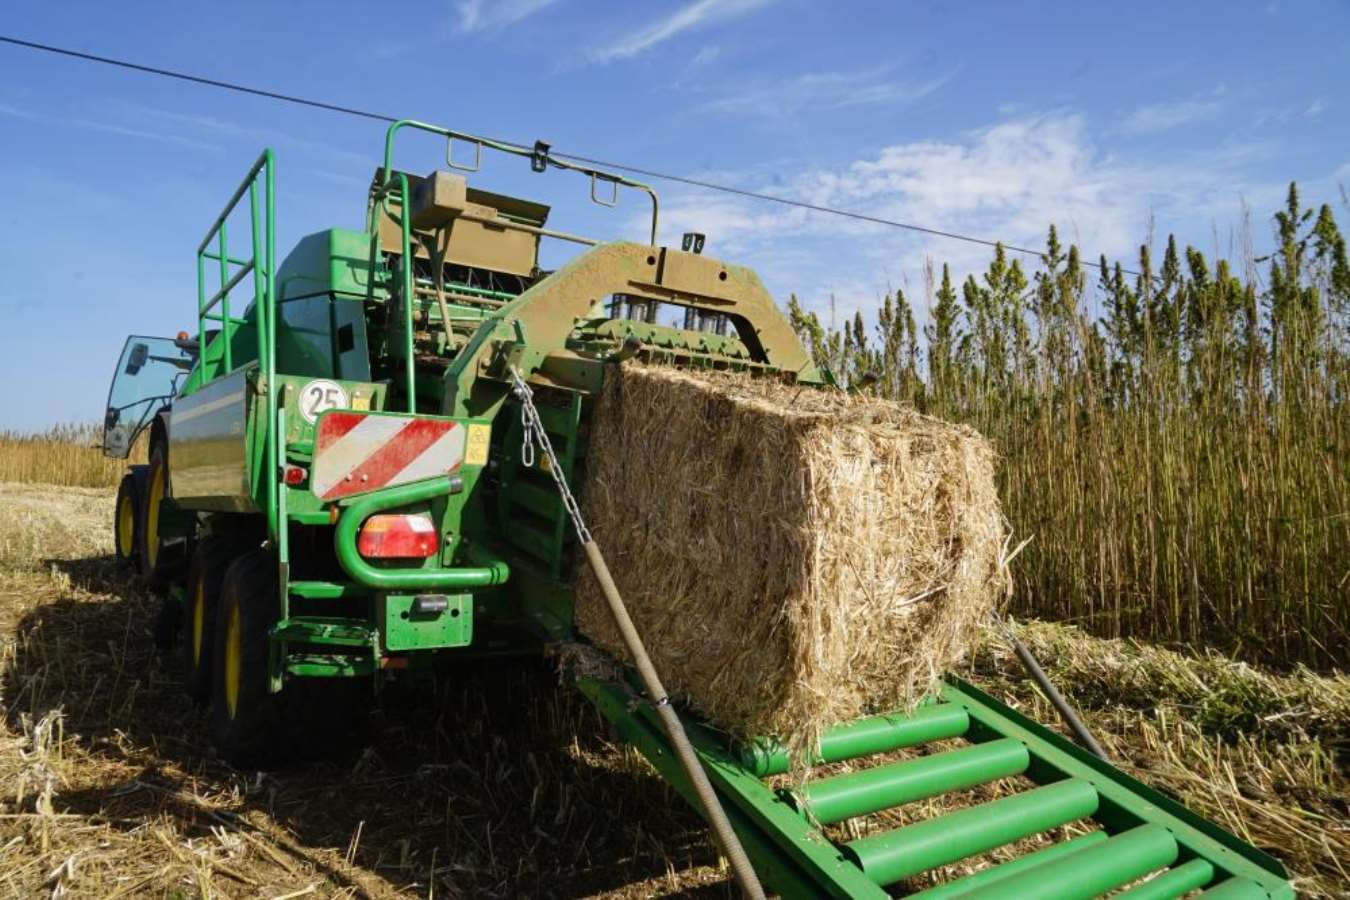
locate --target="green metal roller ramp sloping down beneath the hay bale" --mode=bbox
[578,679,1293,900]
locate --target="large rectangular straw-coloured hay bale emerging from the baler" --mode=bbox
[576,364,1006,758]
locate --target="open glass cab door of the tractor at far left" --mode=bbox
[103,335,193,459]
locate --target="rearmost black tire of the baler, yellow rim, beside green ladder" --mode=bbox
[211,551,374,769]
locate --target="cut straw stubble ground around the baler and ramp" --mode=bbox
[0,484,1350,897]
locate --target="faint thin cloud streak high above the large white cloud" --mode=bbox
[703,65,957,119]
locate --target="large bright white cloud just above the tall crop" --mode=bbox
[642,112,1278,323]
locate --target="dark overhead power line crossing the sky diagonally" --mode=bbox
[0,35,1138,275]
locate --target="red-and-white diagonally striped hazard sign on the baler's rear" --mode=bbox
[309,412,464,501]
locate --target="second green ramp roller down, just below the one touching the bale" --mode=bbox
[797,738,1031,824]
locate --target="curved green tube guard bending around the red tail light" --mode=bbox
[333,476,510,591]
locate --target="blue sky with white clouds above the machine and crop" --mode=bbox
[0,0,1350,429]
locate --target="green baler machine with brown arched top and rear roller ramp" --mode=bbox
[104,120,1293,897]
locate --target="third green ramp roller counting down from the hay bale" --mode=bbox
[844,779,1098,884]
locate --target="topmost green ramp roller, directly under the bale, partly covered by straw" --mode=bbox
[740,703,971,779]
